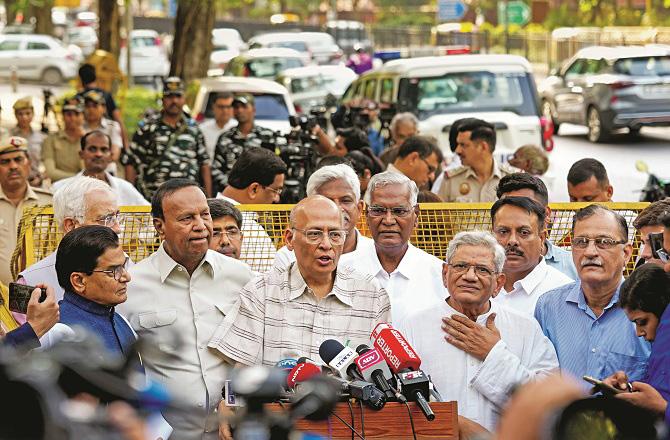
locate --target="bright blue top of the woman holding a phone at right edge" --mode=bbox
[642,306,670,425]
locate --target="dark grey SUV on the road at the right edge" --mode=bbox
[539,46,670,142]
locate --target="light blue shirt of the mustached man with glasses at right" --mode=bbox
[535,281,650,387]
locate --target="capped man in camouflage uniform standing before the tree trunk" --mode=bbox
[121,77,212,200]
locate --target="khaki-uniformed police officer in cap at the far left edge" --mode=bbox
[0,136,51,284]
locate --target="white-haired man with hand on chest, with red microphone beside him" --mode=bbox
[396,231,558,431]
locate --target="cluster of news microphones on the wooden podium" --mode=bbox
[277,324,441,420]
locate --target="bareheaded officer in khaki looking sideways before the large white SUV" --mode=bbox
[436,118,520,203]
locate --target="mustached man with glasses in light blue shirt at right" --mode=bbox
[535,205,650,387]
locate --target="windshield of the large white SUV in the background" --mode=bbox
[399,71,538,120]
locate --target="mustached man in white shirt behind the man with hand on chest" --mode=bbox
[491,196,572,316]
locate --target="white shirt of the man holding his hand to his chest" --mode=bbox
[396,300,558,431]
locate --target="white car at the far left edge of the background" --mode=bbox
[0,34,79,85]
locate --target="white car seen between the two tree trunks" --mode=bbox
[119,29,170,83]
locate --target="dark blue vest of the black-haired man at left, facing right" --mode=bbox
[58,291,136,356]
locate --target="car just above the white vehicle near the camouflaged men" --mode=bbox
[223,48,307,79]
